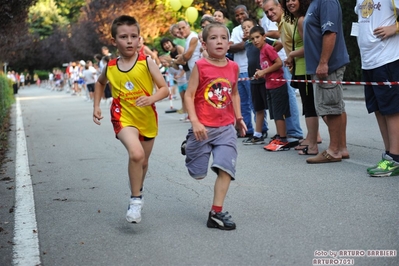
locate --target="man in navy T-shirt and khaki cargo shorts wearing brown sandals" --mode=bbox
[303,0,349,163]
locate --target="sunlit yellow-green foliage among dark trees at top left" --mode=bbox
[28,0,69,39]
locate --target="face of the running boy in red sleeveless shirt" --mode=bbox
[203,27,230,58]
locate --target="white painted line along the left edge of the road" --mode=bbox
[13,97,41,266]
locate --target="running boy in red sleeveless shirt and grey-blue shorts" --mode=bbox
[185,22,247,230]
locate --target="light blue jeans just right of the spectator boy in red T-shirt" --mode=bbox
[283,67,303,138]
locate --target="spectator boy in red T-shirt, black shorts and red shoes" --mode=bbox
[249,26,291,151]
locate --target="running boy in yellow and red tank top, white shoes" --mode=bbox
[93,16,169,223]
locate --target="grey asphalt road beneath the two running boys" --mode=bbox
[0,86,399,266]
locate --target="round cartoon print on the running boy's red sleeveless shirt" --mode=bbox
[204,78,232,109]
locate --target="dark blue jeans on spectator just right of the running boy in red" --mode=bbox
[237,72,268,134]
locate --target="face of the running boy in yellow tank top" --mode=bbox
[112,25,140,57]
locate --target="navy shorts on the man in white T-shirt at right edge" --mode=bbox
[363,60,399,115]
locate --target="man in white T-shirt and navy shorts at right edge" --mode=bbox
[355,0,399,177]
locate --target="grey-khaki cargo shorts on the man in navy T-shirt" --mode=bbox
[312,66,345,116]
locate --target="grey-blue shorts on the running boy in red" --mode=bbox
[186,125,237,180]
